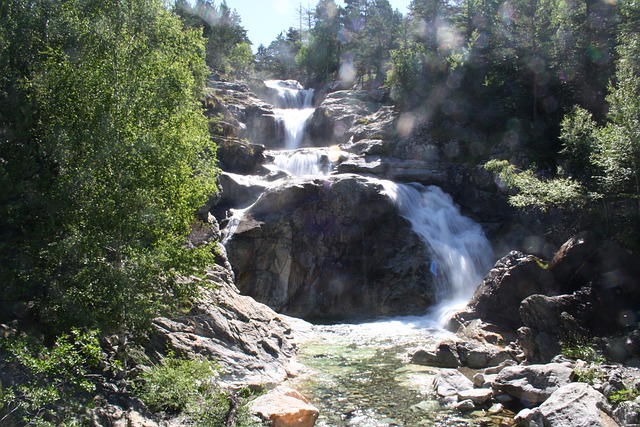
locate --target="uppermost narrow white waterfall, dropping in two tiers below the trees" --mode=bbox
[264,80,314,150]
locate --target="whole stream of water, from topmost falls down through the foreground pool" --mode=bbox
[223,80,504,427]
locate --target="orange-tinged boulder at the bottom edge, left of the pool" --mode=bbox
[250,387,319,427]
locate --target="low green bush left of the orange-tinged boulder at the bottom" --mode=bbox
[136,354,262,427]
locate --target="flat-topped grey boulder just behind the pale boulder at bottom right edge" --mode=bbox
[492,363,573,408]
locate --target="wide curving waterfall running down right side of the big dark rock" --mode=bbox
[383,181,493,325]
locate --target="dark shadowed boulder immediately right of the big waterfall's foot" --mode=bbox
[454,251,559,331]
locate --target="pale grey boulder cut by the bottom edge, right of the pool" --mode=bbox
[538,383,619,427]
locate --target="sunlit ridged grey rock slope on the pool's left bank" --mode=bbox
[149,242,304,384]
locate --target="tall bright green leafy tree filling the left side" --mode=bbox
[0,0,217,332]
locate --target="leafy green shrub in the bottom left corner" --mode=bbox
[0,329,104,426]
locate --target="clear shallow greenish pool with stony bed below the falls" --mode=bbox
[290,317,508,427]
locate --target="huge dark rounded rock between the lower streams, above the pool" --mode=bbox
[227,175,434,318]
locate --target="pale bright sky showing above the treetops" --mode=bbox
[225,0,411,52]
